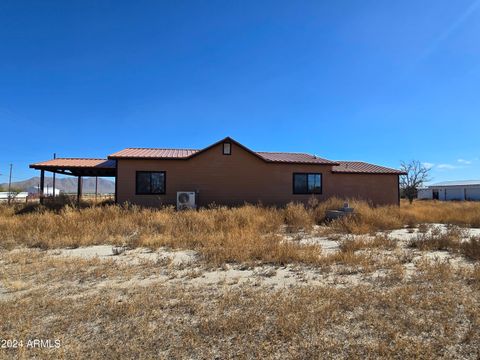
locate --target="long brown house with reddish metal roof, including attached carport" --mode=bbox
[30,137,402,206]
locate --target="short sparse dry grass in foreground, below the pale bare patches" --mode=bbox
[0,250,480,359]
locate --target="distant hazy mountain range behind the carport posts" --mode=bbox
[0,176,115,194]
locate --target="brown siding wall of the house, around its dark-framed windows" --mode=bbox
[117,144,397,206]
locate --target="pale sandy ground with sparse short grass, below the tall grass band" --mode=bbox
[0,224,480,359]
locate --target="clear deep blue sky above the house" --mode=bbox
[0,0,480,186]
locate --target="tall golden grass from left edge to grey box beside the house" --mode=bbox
[0,205,321,264]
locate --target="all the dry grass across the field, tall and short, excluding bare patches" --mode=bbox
[0,199,480,359]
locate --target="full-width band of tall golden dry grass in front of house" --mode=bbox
[0,199,480,264]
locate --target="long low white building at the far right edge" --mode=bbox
[418,180,480,201]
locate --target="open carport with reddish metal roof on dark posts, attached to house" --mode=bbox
[30,158,117,204]
